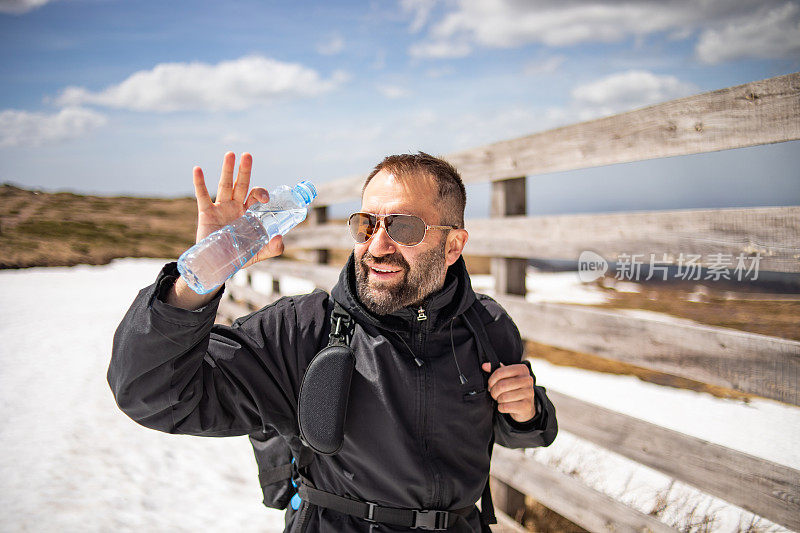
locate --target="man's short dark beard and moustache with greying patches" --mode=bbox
[355,239,447,315]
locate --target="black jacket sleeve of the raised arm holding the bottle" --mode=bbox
[108,263,324,436]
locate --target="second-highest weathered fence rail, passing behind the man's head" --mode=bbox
[285,206,800,272]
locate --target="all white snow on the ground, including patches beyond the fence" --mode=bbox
[0,259,800,532]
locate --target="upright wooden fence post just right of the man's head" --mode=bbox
[491,176,528,296]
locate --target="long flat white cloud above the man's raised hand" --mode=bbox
[56,56,347,112]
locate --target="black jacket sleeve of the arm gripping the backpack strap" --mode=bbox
[481,295,558,448]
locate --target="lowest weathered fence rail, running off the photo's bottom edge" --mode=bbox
[491,446,676,533]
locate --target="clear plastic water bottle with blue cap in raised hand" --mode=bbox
[178,181,317,294]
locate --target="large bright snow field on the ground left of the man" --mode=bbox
[0,259,283,533]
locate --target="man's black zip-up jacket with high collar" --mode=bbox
[108,255,557,532]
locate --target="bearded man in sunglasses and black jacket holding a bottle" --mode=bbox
[108,153,557,532]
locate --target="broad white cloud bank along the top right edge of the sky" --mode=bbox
[404,0,800,62]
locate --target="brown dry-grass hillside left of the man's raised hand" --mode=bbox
[0,185,197,268]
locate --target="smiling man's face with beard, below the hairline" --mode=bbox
[353,170,448,315]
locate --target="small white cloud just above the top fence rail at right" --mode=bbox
[572,70,697,120]
